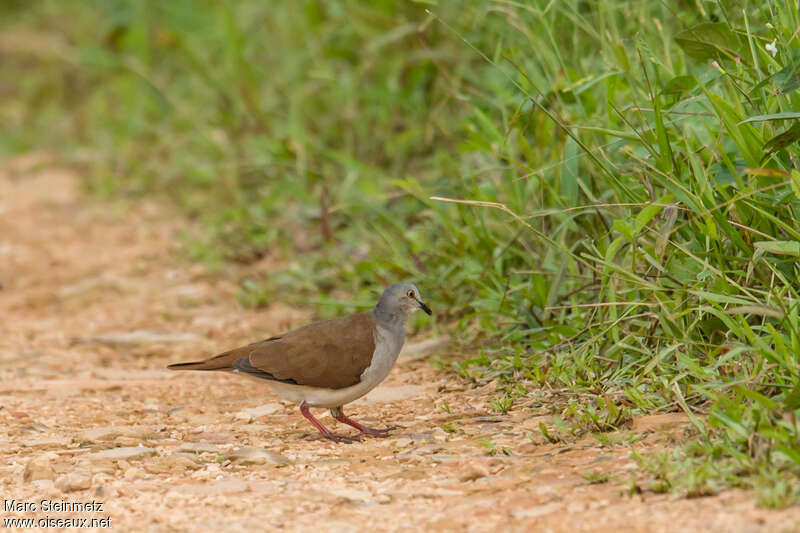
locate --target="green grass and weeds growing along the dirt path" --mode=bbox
[0,0,800,506]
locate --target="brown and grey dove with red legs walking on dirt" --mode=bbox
[167,283,433,442]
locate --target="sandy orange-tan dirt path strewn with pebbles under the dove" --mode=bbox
[0,158,800,532]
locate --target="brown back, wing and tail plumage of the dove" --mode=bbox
[168,311,376,389]
